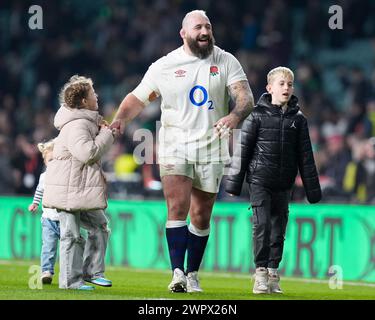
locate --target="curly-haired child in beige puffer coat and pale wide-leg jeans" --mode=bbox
[43,76,118,290]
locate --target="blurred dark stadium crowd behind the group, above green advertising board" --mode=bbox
[0,0,375,204]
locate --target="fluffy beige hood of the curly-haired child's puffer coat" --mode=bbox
[53,106,103,130]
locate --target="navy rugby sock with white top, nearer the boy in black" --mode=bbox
[186,223,210,273]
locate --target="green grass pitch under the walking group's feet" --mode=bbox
[0,261,375,300]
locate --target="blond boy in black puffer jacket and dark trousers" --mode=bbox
[226,67,321,293]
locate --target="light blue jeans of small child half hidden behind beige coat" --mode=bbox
[40,218,60,274]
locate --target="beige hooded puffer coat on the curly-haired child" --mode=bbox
[43,106,114,212]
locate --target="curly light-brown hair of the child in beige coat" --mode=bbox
[59,74,93,109]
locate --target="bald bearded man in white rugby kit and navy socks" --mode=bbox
[112,10,254,292]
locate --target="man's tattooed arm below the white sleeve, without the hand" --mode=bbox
[228,80,254,122]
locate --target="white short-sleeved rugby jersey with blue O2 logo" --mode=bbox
[132,46,247,163]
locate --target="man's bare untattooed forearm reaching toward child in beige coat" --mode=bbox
[112,93,145,132]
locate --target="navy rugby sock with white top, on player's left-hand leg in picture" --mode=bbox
[165,220,188,271]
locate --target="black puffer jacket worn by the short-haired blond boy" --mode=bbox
[226,93,322,203]
